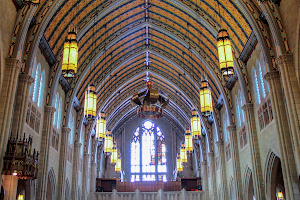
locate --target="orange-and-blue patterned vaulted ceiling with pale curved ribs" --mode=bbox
[36,0,258,134]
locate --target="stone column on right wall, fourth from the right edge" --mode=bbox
[227,125,243,200]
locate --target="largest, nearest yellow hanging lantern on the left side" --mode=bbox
[62,31,78,78]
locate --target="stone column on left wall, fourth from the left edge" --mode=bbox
[57,127,71,199]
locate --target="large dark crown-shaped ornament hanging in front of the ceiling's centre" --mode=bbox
[131,80,169,119]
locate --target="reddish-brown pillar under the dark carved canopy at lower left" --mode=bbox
[3,175,18,200]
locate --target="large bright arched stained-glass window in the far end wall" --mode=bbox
[131,121,167,182]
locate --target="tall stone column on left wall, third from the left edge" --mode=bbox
[36,106,55,199]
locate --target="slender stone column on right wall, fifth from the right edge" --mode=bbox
[216,140,227,199]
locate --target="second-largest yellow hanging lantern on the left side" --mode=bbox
[84,84,97,120]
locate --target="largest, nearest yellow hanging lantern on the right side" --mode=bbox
[217,29,234,80]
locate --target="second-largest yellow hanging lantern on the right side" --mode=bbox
[200,80,213,116]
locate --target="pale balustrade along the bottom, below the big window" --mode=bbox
[92,189,204,200]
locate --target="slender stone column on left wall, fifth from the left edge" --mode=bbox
[71,142,82,200]
